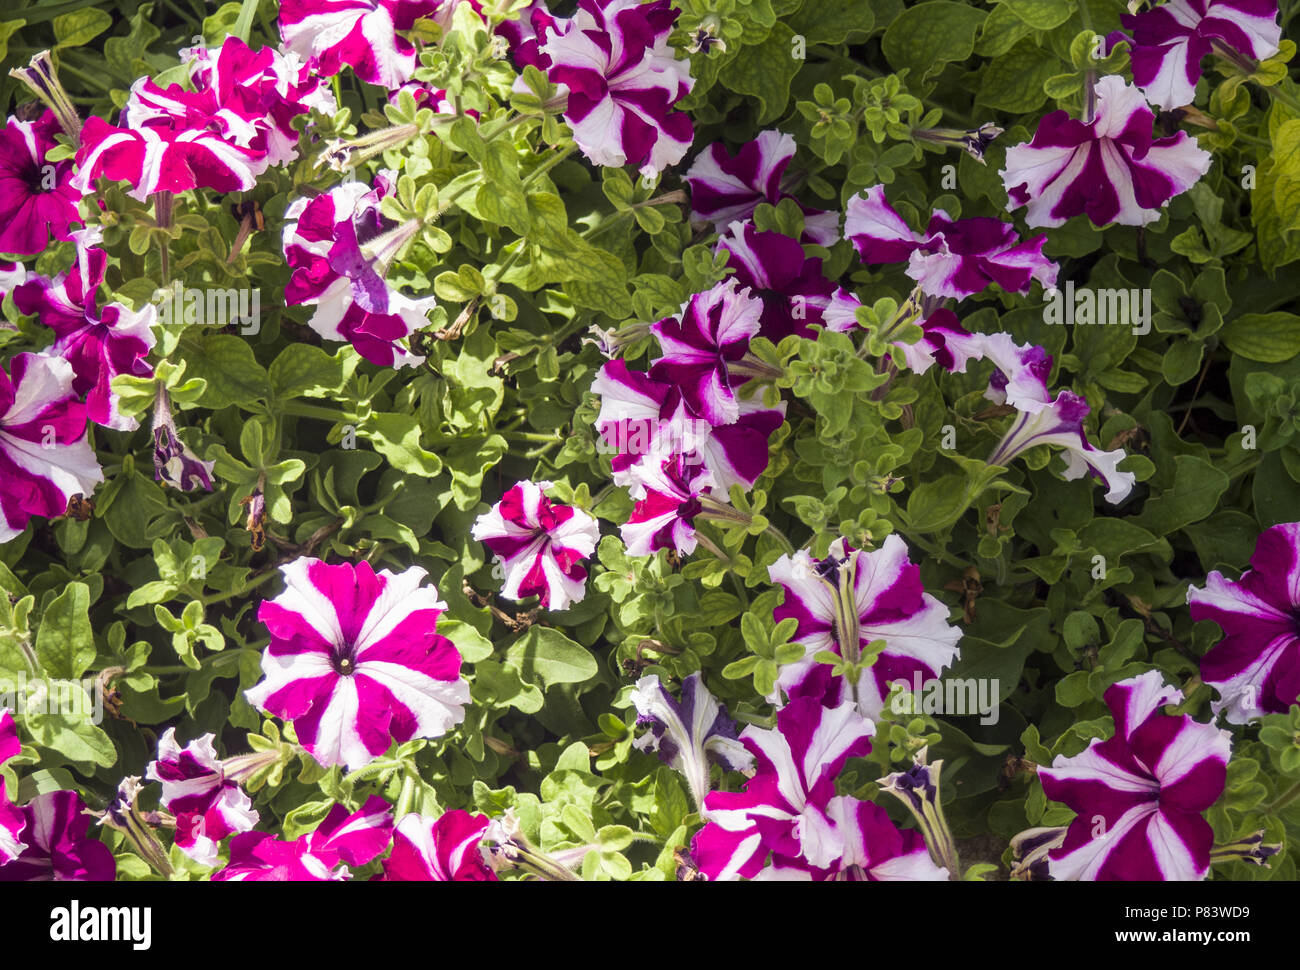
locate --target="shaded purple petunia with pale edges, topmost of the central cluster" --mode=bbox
[681,129,840,247]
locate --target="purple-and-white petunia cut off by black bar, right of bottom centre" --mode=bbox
[754,794,949,883]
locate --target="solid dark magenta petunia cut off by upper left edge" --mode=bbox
[0,109,85,256]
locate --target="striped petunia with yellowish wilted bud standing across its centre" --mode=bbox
[767,527,962,718]
